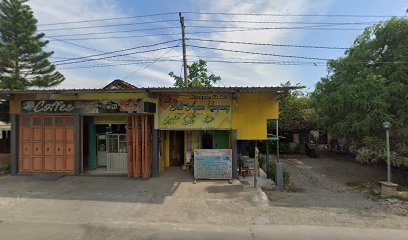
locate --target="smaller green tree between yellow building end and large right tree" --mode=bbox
[279,82,318,131]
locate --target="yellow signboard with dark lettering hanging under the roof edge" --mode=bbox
[159,94,232,129]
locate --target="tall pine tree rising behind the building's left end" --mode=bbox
[0,0,65,89]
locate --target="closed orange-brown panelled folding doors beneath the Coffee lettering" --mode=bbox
[19,115,75,174]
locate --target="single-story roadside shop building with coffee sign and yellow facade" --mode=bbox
[0,84,292,178]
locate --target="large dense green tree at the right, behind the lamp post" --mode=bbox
[313,18,408,165]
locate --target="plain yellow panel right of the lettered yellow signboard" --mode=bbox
[232,92,279,140]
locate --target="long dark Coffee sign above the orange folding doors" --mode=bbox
[21,99,142,113]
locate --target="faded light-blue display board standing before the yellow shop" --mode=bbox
[194,149,232,180]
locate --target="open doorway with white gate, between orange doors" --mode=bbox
[83,117,127,174]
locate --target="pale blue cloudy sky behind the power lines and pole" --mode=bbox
[29,0,408,91]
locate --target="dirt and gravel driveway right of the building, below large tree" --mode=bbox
[266,152,408,222]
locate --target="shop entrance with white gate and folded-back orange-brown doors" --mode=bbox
[82,114,153,178]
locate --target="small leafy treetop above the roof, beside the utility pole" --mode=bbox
[169,59,221,88]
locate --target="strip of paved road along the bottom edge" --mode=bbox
[0,221,408,240]
